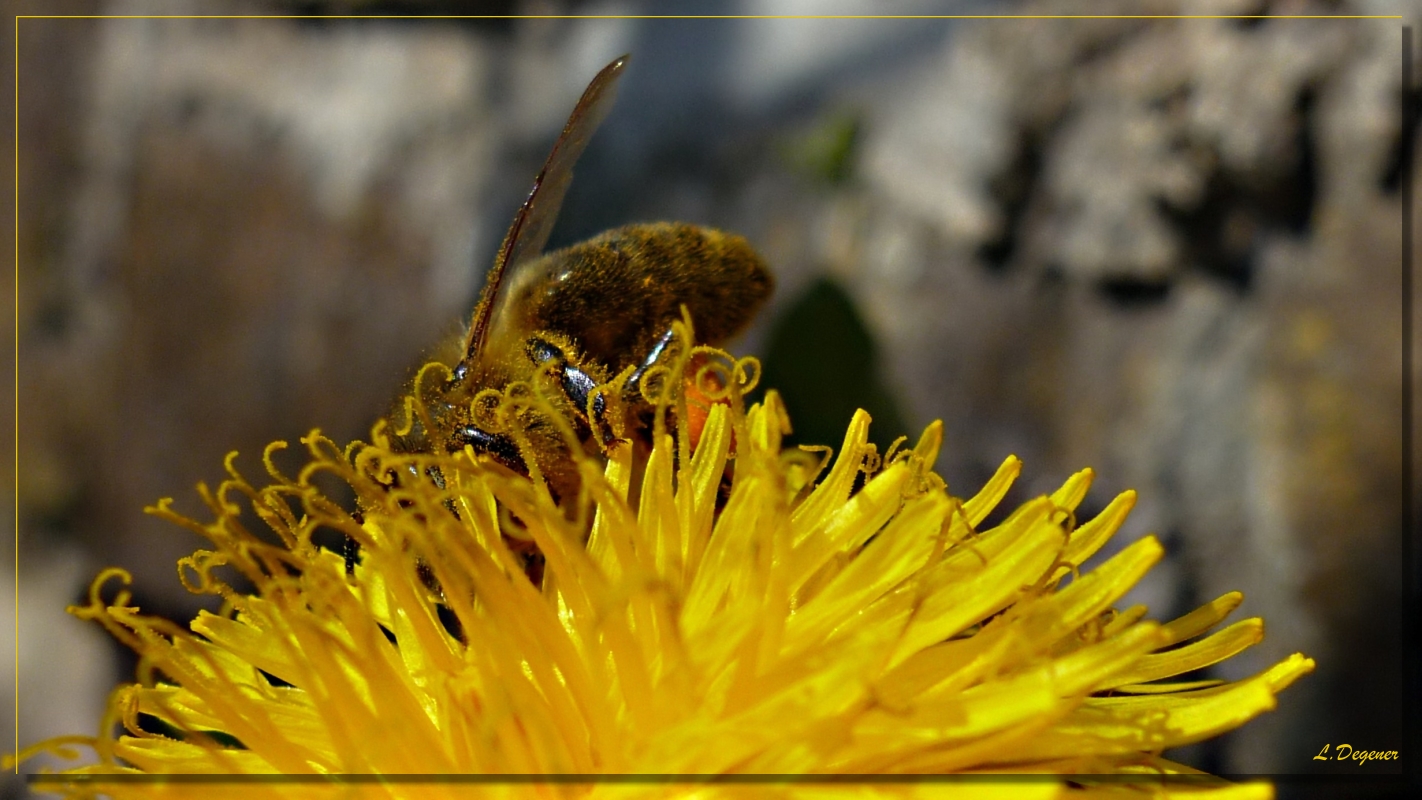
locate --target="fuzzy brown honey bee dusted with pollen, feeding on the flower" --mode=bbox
[392,55,774,497]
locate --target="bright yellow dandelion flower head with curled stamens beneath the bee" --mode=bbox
[8,341,1313,799]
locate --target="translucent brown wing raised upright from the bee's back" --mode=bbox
[462,55,629,367]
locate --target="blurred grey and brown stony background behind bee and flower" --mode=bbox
[0,0,1422,797]
